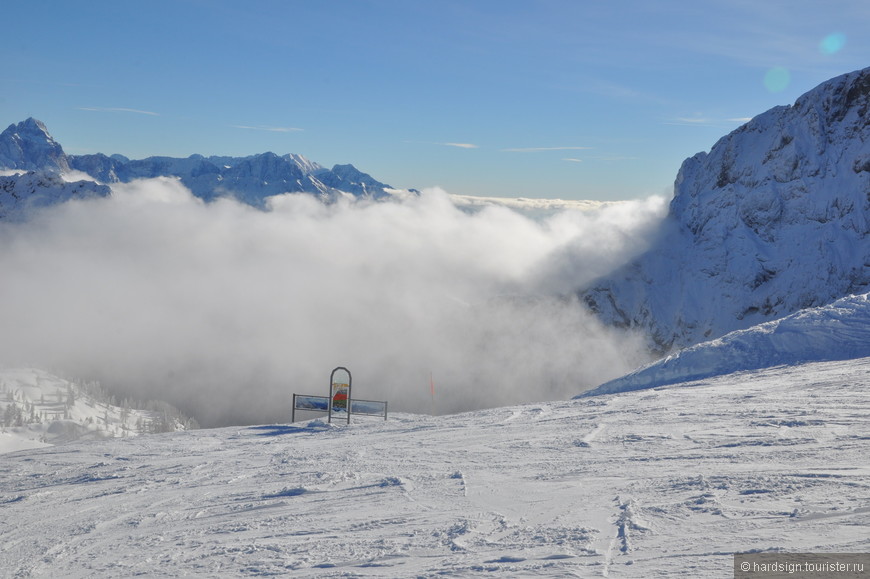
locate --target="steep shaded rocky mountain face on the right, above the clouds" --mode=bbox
[579,68,870,352]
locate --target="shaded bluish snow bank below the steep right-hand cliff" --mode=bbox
[582,294,870,396]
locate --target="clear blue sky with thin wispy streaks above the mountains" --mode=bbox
[0,0,870,200]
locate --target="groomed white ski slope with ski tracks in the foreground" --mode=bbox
[0,358,870,578]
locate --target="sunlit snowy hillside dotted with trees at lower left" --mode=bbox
[0,368,191,454]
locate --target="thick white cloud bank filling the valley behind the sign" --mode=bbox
[0,179,664,426]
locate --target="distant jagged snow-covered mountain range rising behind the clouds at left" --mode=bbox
[0,118,408,207]
